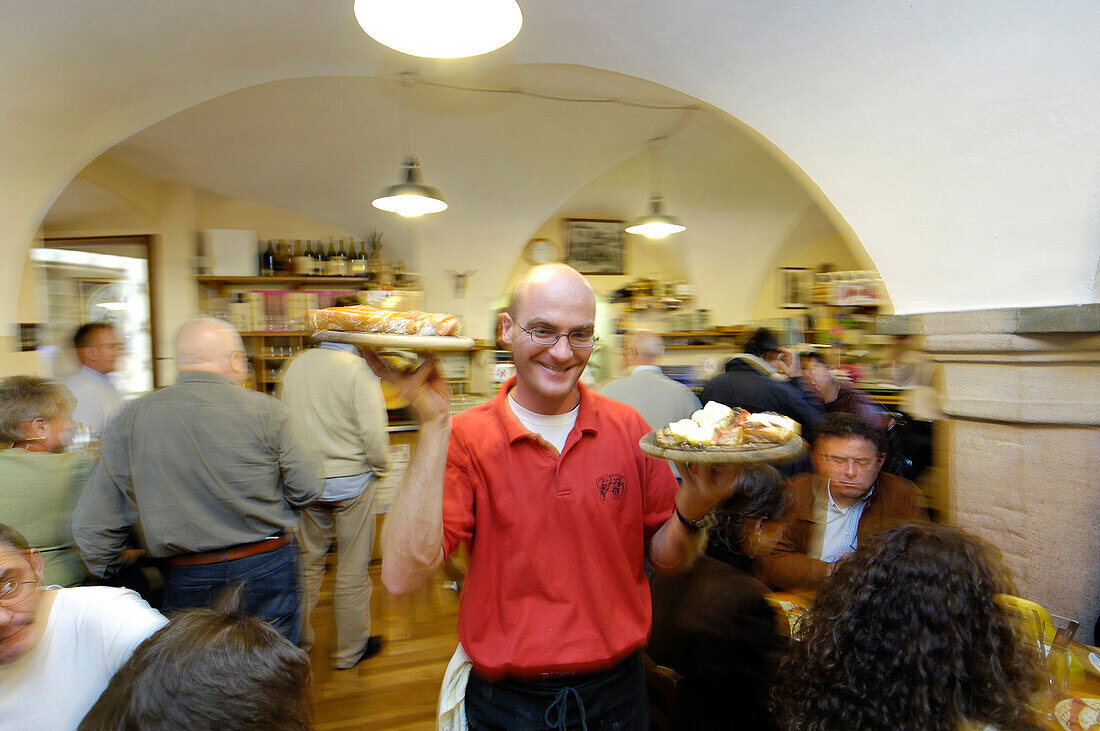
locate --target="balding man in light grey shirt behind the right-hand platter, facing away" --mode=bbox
[600,331,701,429]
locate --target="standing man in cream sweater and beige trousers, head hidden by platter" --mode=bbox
[281,323,389,669]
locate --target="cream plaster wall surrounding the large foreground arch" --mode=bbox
[0,0,1100,320]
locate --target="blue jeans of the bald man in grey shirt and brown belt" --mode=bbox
[163,543,300,644]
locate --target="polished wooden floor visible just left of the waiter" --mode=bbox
[310,556,459,731]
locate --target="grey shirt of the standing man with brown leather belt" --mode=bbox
[73,372,325,576]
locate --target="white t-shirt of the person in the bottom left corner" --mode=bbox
[0,586,168,731]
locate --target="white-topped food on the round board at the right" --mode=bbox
[655,401,801,450]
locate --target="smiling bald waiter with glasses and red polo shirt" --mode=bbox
[369,264,736,729]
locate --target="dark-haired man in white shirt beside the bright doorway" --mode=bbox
[65,322,125,442]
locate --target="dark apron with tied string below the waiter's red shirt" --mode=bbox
[465,653,649,731]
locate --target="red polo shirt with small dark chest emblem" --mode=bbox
[443,378,677,678]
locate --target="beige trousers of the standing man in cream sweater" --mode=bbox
[300,478,378,668]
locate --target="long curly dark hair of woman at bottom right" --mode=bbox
[772,523,1038,731]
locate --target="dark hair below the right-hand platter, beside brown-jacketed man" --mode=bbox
[706,464,791,573]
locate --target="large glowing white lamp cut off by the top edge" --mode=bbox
[355,0,524,58]
